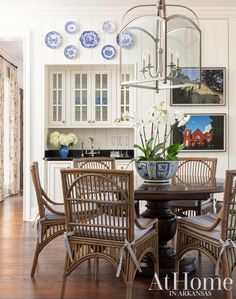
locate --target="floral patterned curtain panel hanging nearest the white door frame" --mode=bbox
[9,66,20,195]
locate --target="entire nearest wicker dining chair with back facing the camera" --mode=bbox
[61,168,158,299]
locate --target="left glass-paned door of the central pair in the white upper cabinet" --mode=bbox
[72,71,91,124]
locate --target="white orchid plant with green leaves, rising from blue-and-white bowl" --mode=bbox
[115,102,190,161]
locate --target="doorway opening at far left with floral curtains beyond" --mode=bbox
[0,40,23,197]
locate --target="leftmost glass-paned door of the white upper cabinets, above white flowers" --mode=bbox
[49,71,66,126]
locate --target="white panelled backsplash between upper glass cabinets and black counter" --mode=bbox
[46,128,134,150]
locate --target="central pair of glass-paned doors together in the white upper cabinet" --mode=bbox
[71,69,112,126]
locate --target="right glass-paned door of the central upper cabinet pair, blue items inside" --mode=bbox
[92,71,111,124]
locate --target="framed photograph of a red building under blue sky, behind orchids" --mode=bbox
[171,114,226,151]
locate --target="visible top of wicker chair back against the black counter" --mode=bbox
[73,157,116,169]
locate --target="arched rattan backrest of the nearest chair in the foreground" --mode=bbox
[61,168,134,241]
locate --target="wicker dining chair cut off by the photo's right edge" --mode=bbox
[176,170,236,299]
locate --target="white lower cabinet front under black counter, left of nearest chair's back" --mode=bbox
[45,161,73,202]
